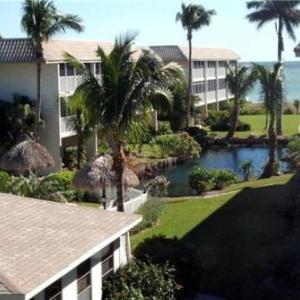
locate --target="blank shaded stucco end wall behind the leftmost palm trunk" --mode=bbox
[0,63,60,171]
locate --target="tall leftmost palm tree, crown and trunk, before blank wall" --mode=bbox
[21,0,83,140]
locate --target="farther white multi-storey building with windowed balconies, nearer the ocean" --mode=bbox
[150,45,240,109]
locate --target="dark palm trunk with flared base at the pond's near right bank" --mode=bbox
[261,111,278,178]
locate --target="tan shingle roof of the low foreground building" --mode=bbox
[0,193,141,294]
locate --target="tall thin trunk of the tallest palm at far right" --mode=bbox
[276,18,284,135]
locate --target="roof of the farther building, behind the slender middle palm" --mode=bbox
[150,45,240,61]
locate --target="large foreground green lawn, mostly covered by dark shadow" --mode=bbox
[132,175,299,299]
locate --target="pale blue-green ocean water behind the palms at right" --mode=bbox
[244,60,300,102]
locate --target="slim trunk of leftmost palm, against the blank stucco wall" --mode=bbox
[34,45,43,142]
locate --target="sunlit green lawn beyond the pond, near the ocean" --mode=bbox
[207,115,300,137]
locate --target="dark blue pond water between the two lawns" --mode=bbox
[162,147,292,196]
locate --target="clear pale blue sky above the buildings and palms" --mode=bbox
[0,0,300,61]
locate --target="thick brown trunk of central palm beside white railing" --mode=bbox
[107,133,126,212]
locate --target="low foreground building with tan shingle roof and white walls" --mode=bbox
[0,194,141,300]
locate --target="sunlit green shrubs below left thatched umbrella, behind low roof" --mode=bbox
[8,175,73,202]
